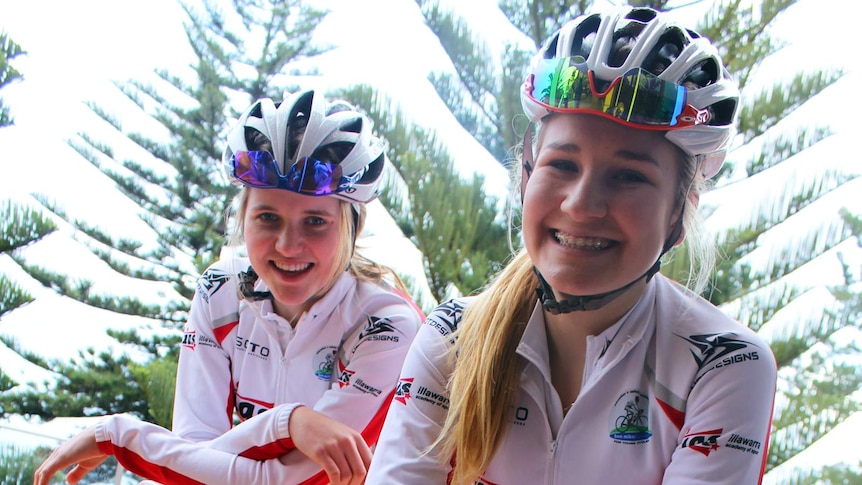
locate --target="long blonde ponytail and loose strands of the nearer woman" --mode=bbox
[436,119,715,485]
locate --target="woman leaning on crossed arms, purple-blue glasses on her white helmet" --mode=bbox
[35,91,423,485]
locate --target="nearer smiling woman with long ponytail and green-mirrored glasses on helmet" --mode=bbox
[366,4,776,485]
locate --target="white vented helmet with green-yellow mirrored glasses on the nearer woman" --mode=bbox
[521,8,739,178]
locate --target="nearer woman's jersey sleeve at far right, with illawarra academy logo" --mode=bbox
[662,334,777,485]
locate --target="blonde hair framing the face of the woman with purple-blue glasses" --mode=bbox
[227,187,409,294]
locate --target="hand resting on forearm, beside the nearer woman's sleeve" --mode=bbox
[288,406,371,485]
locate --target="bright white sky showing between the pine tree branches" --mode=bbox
[0,0,862,483]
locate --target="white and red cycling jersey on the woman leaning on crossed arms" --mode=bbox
[91,255,423,485]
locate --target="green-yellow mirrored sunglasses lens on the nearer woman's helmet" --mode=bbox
[527,56,705,129]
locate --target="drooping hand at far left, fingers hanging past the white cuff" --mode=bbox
[33,426,108,485]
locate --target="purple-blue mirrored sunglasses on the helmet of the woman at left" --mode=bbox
[231,151,356,195]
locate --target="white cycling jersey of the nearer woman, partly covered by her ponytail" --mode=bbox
[366,275,777,485]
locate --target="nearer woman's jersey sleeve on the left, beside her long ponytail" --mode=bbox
[366,319,450,485]
